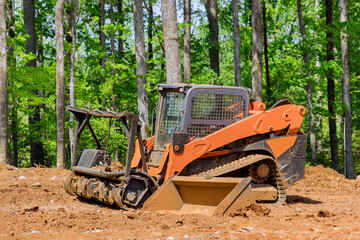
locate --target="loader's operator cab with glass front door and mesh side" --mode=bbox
[149,84,250,166]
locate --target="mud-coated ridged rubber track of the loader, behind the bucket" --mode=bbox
[191,154,286,205]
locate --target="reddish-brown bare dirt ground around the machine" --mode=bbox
[0,165,360,240]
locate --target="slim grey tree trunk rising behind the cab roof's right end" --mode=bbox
[232,0,241,87]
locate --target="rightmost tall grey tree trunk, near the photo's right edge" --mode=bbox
[339,0,355,179]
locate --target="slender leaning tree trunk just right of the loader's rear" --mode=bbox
[297,0,316,165]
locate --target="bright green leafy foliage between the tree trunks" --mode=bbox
[7,0,360,174]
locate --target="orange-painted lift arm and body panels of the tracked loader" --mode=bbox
[131,86,306,184]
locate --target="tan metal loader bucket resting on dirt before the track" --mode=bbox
[144,176,255,215]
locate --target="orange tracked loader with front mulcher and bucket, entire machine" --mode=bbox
[65,84,306,215]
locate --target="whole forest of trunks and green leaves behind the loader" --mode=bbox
[0,0,360,178]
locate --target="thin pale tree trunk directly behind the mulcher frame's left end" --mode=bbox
[68,0,79,166]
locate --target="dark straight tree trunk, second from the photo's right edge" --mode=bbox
[325,0,339,171]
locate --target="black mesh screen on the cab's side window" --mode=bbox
[187,92,247,138]
